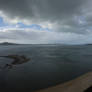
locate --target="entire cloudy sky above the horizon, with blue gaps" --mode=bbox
[0,0,92,44]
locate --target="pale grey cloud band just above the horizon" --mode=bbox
[0,28,92,44]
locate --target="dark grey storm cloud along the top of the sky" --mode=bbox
[0,0,87,25]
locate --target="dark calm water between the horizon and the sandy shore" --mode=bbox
[0,45,92,92]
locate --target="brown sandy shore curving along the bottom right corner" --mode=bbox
[36,72,92,92]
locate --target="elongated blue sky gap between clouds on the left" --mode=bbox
[0,17,50,31]
